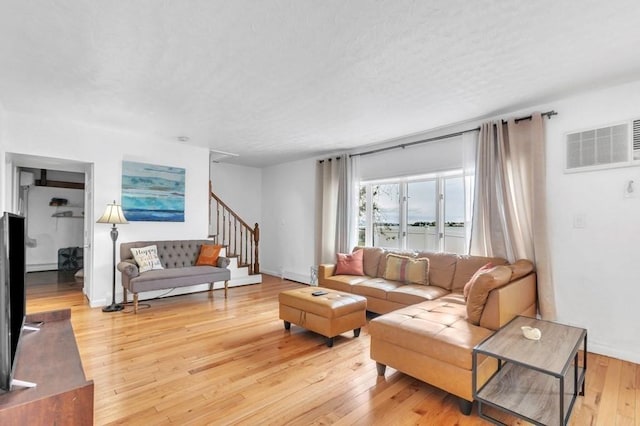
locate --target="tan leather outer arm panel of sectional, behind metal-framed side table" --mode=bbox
[480,272,537,330]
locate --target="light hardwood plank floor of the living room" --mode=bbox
[27,276,640,425]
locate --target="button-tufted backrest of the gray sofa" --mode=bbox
[120,240,213,269]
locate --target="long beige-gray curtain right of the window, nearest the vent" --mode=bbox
[470,113,556,320]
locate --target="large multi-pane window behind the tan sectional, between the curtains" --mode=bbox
[358,172,467,254]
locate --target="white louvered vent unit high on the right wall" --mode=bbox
[565,119,640,173]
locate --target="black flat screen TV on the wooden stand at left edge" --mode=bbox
[0,213,26,391]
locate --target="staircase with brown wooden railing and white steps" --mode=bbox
[209,182,262,287]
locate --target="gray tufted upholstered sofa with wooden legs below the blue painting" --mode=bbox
[118,240,231,313]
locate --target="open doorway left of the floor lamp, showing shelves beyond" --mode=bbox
[7,154,94,300]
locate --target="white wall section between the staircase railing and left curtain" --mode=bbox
[260,159,317,283]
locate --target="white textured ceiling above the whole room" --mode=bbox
[0,0,640,166]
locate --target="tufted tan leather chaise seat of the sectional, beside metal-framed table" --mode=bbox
[369,300,493,371]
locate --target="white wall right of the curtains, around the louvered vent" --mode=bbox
[546,82,640,363]
